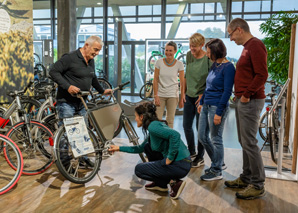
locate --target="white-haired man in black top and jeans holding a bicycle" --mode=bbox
[49,36,111,166]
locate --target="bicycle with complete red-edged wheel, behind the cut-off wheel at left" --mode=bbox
[0,82,53,175]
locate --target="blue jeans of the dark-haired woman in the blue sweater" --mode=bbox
[199,104,229,174]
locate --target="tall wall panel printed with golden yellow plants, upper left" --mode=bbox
[0,0,33,101]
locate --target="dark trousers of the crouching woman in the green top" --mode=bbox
[135,143,191,188]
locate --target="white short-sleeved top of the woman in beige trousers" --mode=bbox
[155,59,184,98]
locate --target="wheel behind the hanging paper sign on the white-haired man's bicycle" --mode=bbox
[54,126,103,184]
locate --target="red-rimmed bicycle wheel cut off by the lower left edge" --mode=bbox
[0,135,24,195]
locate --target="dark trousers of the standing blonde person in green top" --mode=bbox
[183,95,205,158]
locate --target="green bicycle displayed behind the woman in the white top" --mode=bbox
[148,44,186,72]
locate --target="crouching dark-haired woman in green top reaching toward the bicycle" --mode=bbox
[109,102,191,199]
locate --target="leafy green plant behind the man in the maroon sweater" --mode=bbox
[260,12,298,83]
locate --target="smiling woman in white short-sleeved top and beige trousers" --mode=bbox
[153,41,184,128]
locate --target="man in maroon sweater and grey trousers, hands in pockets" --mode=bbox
[225,18,268,199]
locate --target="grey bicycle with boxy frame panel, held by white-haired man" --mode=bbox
[53,82,146,184]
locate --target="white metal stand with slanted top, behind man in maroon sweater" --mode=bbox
[265,78,297,181]
